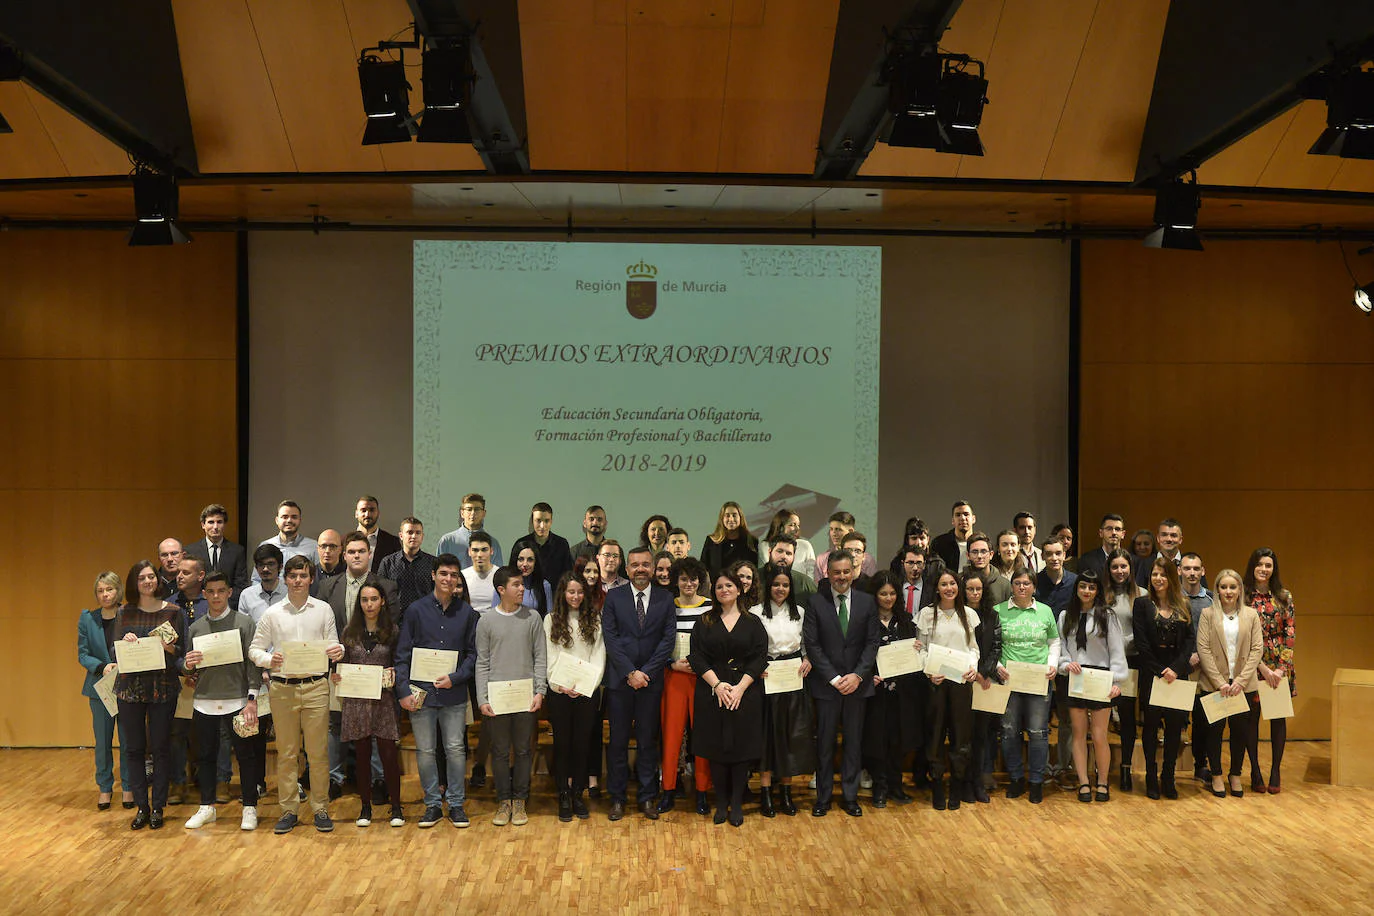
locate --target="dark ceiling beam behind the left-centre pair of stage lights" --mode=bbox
[407,0,529,174]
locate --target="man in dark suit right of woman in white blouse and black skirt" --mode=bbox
[801,551,878,817]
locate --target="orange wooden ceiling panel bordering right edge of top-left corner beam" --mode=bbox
[172,0,297,174]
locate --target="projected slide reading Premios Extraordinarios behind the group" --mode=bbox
[414,240,882,551]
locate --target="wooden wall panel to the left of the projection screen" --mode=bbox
[0,232,239,746]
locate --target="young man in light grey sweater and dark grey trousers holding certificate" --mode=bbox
[477,566,548,827]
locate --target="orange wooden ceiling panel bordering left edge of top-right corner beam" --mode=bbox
[1044,0,1169,181]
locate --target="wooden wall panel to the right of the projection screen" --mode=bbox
[1077,242,1374,737]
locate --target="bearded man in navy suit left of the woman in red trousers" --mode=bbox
[602,547,676,821]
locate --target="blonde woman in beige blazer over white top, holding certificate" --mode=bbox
[1197,570,1264,798]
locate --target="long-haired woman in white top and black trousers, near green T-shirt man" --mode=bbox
[916,570,978,810]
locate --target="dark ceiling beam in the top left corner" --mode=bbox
[0,0,198,176]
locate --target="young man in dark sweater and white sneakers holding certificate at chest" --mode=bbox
[181,573,262,829]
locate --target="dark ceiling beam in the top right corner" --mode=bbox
[1135,0,1374,184]
